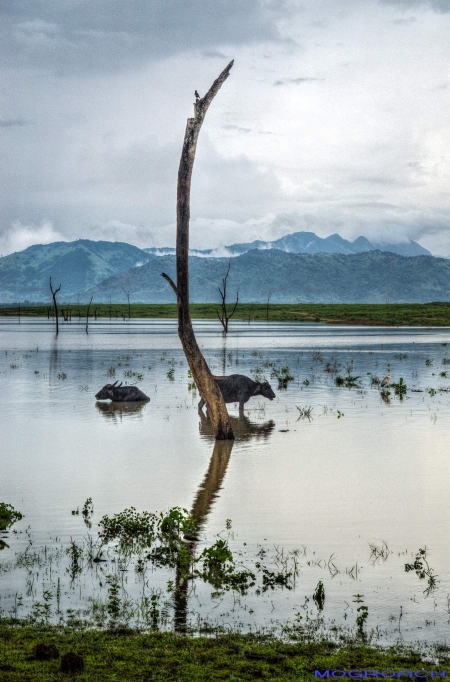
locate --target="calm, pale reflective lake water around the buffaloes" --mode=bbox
[0,319,450,641]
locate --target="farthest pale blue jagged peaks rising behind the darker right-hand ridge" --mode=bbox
[144,232,431,258]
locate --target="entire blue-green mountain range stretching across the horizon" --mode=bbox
[0,232,442,303]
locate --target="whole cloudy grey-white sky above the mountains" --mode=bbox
[0,0,450,256]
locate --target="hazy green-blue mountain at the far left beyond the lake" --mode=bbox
[0,239,155,303]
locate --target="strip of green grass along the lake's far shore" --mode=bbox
[0,302,450,327]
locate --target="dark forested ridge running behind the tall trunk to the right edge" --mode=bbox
[73,249,450,303]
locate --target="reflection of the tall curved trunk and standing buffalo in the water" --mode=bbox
[174,410,275,633]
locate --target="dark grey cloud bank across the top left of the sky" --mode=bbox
[0,0,277,75]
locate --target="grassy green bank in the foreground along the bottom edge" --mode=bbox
[0,621,448,682]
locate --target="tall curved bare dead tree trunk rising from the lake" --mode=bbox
[162,60,234,440]
